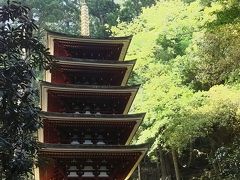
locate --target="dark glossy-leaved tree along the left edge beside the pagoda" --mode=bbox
[0,1,52,180]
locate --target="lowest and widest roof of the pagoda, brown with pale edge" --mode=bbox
[39,143,148,180]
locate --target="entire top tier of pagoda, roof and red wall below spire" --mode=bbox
[47,31,132,61]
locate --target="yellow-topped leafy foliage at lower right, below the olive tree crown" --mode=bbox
[163,86,240,148]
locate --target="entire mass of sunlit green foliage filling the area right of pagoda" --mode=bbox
[112,0,240,179]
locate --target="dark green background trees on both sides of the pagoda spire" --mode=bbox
[0,0,120,38]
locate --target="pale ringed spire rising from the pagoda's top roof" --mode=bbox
[81,0,90,36]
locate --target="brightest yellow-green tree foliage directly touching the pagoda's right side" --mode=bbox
[113,1,208,149]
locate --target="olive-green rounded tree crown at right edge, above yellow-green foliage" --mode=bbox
[183,24,240,90]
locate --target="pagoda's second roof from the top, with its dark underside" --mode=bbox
[53,56,136,86]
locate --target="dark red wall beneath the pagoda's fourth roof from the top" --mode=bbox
[44,122,127,145]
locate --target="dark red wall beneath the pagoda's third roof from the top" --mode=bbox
[48,94,130,114]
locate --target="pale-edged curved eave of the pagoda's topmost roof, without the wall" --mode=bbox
[47,30,132,61]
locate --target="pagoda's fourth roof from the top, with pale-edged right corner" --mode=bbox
[40,111,145,145]
